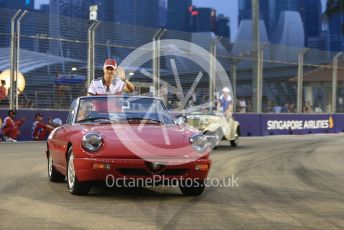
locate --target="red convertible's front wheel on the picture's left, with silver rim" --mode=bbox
[67,147,91,195]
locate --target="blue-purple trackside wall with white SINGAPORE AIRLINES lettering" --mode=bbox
[0,110,344,141]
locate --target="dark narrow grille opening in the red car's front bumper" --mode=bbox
[117,168,188,176]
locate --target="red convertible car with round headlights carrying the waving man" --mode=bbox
[46,96,213,196]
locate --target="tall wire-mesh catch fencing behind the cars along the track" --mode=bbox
[0,9,344,114]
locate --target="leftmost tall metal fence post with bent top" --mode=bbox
[9,9,21,109]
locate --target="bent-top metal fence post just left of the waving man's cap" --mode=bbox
[86,21,100,91]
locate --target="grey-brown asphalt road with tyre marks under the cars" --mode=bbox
[0,134,344,229]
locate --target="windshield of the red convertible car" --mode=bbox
[75,96,174,124]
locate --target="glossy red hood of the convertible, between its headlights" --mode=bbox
[79,124,200,159]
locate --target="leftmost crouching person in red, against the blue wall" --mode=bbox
[1,110,25,142]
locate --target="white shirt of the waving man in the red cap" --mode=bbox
[87,77,125,95]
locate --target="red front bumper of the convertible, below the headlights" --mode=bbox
[74,158,211,181]
